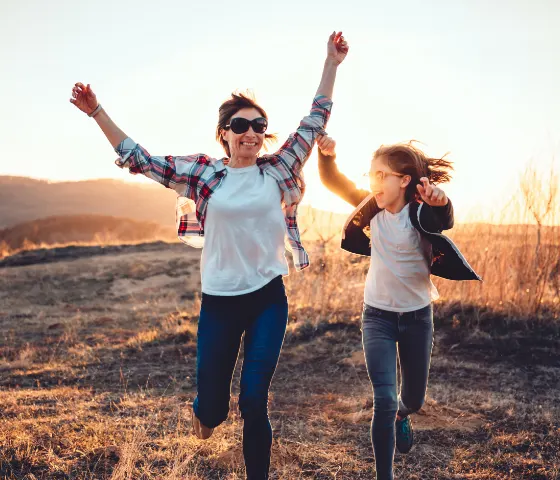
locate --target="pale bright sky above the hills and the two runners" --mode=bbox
[0,0,560,225]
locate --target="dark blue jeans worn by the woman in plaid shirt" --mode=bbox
[193,277,288,480]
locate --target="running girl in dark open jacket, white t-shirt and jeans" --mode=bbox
[318,136,481,480]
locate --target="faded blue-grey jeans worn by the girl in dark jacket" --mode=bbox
[362,304,434,480]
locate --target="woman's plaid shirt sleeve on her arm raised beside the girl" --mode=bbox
[274,95,332,173]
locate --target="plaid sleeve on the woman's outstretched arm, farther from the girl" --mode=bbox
[115,138,211,201]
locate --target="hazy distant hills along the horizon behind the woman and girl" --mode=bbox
[0,176,560,255]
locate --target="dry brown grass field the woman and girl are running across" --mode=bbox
[0,216,560,480]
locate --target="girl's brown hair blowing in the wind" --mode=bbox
[373,140,453,202]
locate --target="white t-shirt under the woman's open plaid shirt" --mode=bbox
[200,165,288,296]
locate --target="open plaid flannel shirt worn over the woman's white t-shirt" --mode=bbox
[115,95,332,270]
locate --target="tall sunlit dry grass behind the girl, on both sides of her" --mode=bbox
[287,159,560,322]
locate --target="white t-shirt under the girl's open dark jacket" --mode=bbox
[364,204,439,312]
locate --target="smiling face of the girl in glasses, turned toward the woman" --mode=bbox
[369,156,411,210]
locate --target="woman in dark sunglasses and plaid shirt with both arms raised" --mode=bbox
[70,32,348,480]
